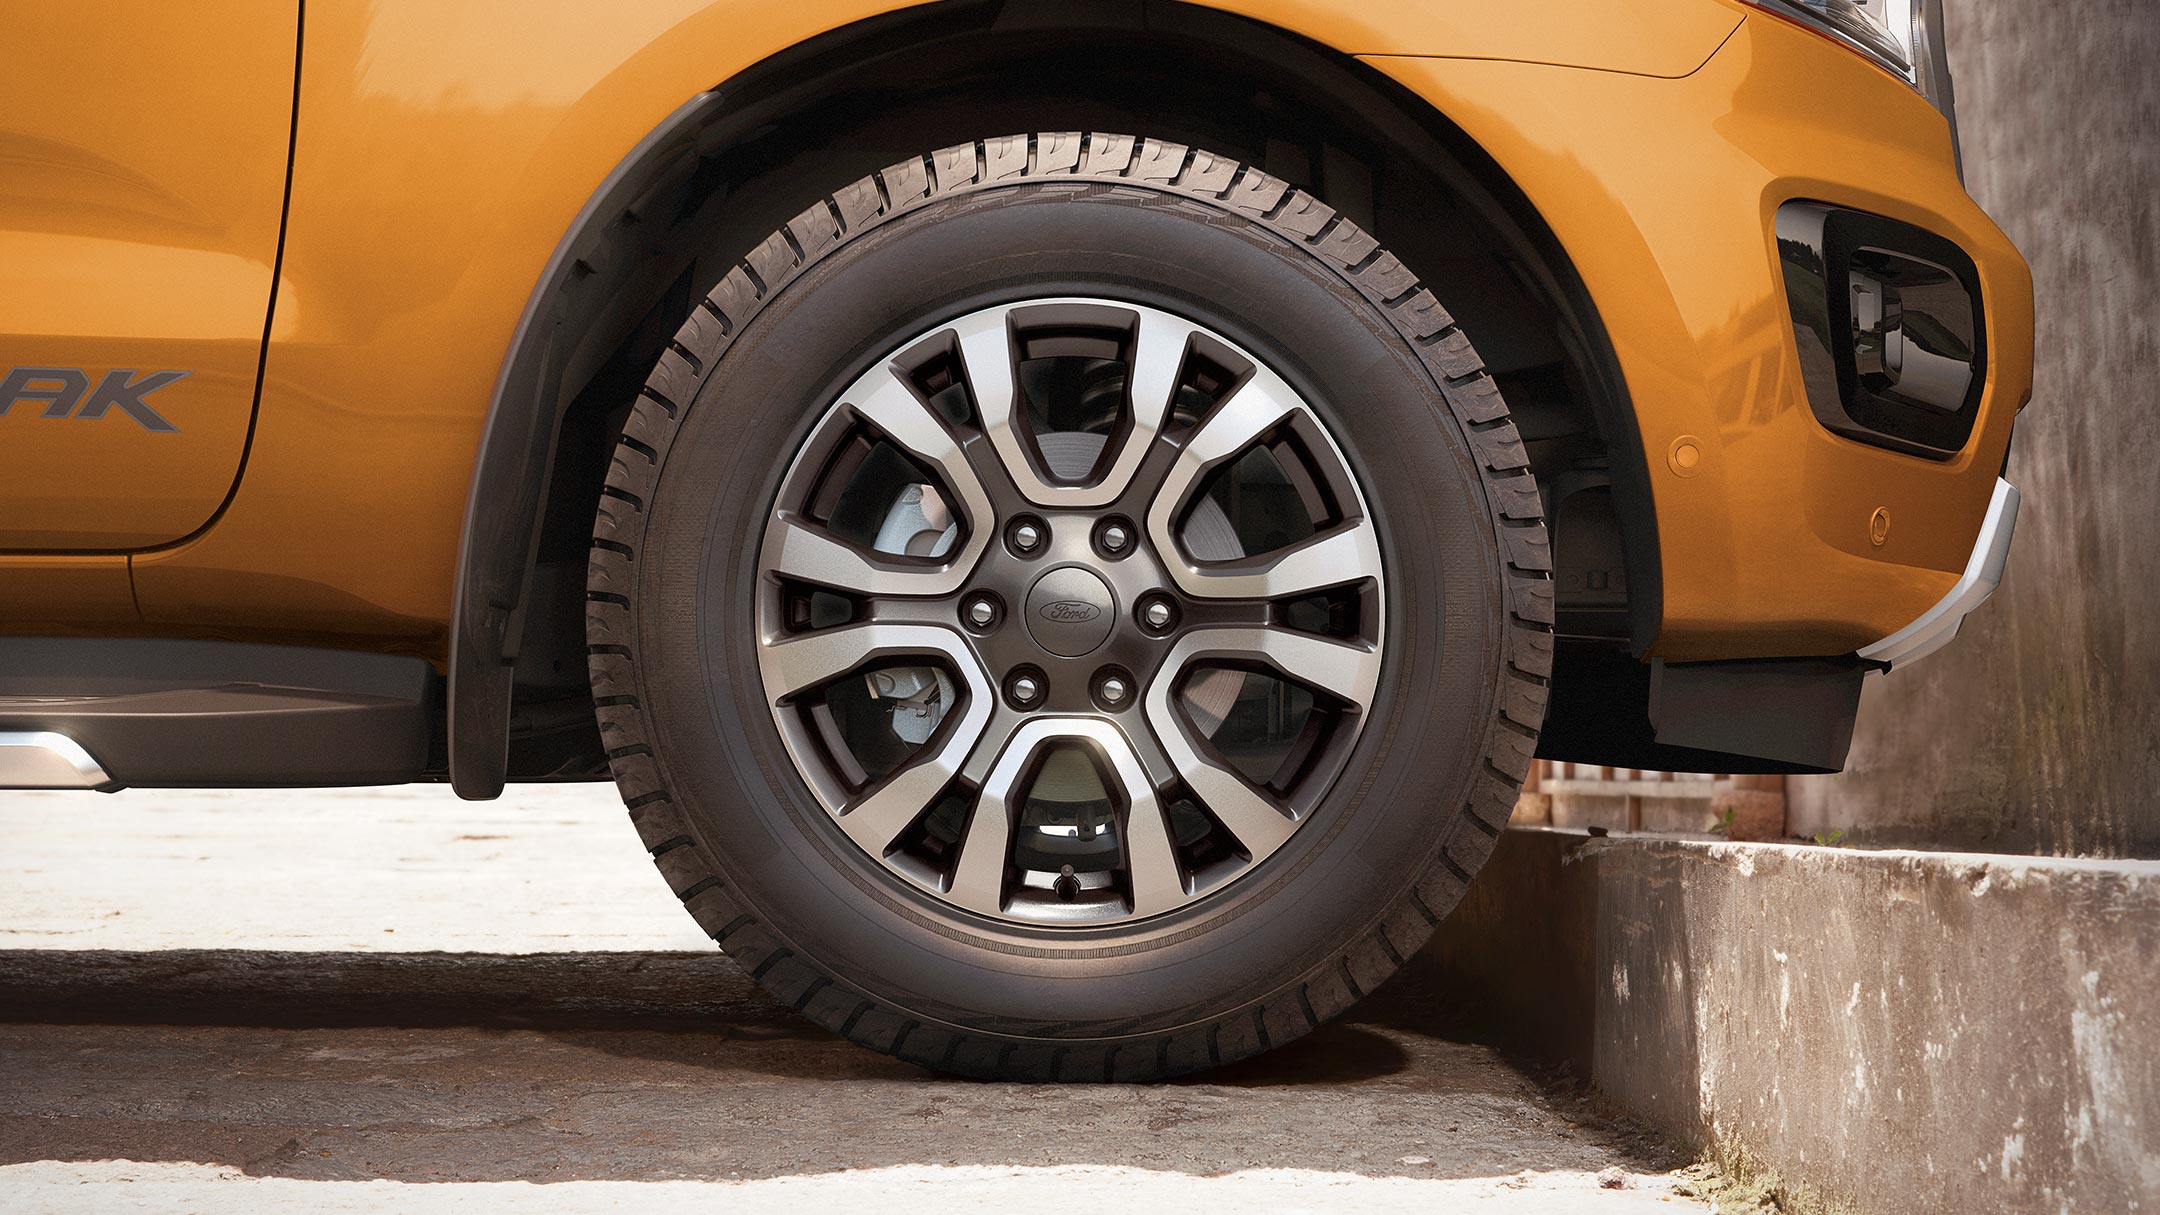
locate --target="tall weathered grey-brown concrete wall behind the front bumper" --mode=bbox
[1791,0,2160,856]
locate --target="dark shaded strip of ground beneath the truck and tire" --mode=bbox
[0,949,1676,1180]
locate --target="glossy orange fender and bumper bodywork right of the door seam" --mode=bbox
[0,0,2030,659]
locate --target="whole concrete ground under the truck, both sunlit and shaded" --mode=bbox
[0,787,1711,1215]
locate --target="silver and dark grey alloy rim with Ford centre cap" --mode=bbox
[756,296,1387,927]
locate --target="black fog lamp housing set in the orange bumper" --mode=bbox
[1778,201,1987,460]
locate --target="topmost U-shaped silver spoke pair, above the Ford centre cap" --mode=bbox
[955,309,1194,508]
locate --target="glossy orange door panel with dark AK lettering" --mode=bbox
[0,0,298,551]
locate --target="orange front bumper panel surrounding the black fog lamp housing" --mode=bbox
[1369,7,2033,662]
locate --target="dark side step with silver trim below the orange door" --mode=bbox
[0,638,441,791]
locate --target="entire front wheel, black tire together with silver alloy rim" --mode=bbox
[588,134,1551,1081]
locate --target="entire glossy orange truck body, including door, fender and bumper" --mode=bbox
[0,0,2033,687]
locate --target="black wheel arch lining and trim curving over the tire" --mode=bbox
[447,0,1659,798]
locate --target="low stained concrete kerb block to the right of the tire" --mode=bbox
[1406,830,2160,1215]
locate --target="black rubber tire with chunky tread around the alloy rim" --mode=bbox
[588,134,1553,1081]
